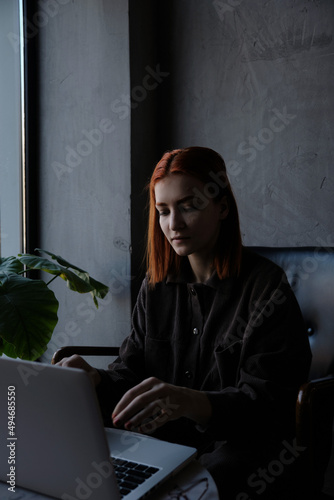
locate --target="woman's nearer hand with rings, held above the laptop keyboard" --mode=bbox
[112,377,212,434]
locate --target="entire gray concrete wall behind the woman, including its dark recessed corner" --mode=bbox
[38,0,334,364]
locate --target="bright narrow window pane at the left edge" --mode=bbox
[0,0,25,257]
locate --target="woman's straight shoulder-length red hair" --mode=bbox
[146,147,242,285]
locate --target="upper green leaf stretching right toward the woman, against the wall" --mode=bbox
[18,248,109,307]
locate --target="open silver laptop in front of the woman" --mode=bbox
[0,358,196,500]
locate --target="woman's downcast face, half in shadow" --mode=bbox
[155,174,228,258]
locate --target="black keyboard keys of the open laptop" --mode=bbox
[111,457,159,498]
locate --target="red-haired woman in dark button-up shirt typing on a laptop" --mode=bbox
[61,147,311,500]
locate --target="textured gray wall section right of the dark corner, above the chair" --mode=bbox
[157,0,334,246]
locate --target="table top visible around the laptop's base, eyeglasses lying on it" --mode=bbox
[0,460,219,500]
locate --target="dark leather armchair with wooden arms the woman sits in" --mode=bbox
[52,247,334,500]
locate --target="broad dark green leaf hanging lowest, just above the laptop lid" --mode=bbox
[0,273,58,360]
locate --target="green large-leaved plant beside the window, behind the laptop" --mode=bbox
[0,248,108,361]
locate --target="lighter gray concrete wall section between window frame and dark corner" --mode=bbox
[36,0,131,366]
